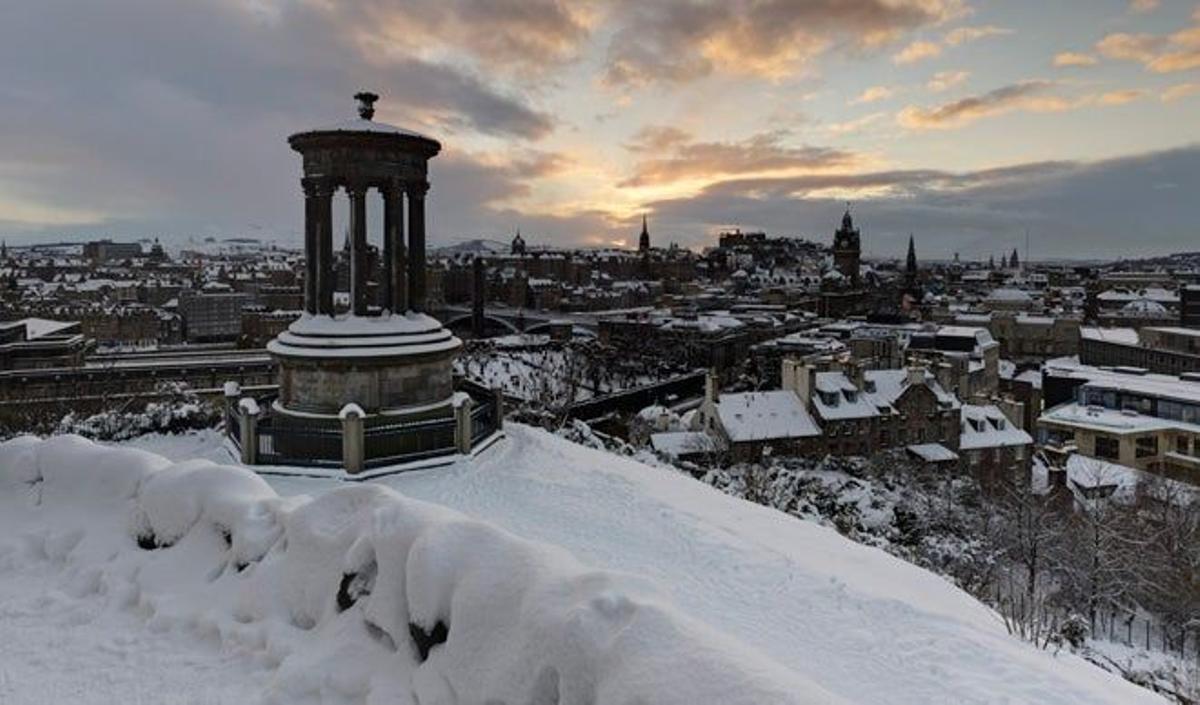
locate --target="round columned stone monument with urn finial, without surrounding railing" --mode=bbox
[268,94,462,420]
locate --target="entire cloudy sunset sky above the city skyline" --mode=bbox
[0,0,1200,258]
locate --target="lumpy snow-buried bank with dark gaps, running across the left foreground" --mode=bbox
[0,436,840,705]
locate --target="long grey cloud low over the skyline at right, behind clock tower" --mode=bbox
[652,146,1200,258]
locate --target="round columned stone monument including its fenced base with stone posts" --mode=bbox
[227,92,500,472]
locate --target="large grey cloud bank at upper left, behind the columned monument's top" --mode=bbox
[0,0,553,239]
